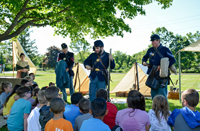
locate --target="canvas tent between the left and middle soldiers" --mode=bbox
[66,63,90,94]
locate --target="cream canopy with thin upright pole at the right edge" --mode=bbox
[178,39,200,102]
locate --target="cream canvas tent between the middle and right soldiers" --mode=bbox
[111,63,151,97]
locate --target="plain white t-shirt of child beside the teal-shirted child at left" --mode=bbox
[27,107,41,131]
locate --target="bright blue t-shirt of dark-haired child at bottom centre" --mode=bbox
[80,118,111,131]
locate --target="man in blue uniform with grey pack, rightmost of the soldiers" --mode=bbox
[142,34,176,99]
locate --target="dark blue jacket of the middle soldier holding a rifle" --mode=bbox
[84,51,115,81]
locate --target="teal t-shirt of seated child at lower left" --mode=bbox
[7,98,31,131]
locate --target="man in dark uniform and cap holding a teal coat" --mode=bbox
[57,43,74,101]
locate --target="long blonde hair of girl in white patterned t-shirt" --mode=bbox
[152,95,170,121]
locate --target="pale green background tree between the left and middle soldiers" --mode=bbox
[69,40,91,63]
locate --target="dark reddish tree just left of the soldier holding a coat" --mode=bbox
[43,46,61,68]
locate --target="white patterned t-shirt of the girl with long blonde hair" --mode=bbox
[148,109,171,131]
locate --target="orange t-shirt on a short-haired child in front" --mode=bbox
[44,118,74,131]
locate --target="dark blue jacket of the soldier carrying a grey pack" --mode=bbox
[142,44,176,74]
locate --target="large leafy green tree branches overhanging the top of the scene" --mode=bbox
[0,0,173,42]
